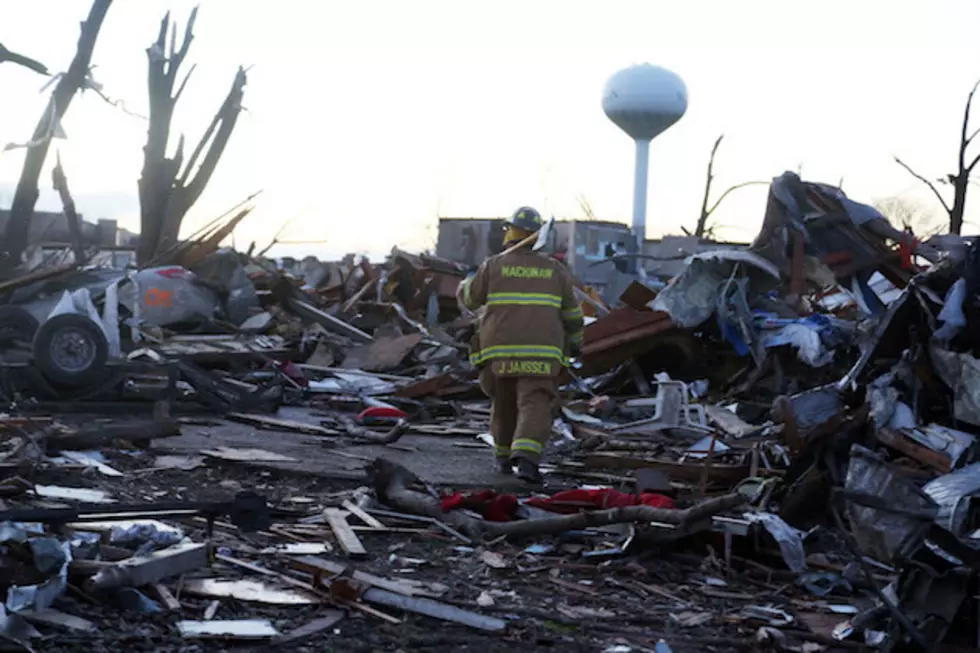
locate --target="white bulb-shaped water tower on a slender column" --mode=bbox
[602,63,687,251]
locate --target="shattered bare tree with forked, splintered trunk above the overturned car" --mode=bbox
[137,8,246,264]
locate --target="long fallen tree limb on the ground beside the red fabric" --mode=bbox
[368,458,746,539]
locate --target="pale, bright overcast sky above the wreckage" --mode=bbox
[0,0,980,257]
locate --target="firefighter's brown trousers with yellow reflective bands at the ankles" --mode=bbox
[480,365,558,463]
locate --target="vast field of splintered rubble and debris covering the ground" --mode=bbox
[0,173,980,652]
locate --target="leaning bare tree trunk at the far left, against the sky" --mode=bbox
[0,0,112,276]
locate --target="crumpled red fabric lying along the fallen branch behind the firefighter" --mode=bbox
[442,488,675,521]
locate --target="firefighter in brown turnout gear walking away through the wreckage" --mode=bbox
[457,206,583,484]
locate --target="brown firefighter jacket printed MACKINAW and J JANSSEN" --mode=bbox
[457,249,583,376]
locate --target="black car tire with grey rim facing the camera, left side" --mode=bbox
[33,313,109,387]
